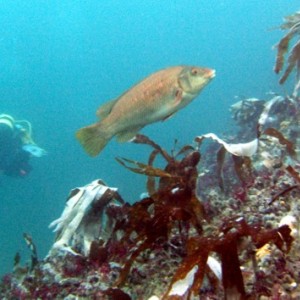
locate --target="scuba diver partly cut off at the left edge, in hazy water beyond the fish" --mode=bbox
[0,114,46,177]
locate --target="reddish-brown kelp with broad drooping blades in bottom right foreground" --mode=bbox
[163,218,293,300]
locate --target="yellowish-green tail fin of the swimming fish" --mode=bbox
[76,124,110,156]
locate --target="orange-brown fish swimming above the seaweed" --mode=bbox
[76,66,215,157]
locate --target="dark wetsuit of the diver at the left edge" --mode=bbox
[0,123,31,177]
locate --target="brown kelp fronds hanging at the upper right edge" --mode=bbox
[274,12,300,84]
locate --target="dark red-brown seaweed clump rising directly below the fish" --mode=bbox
[113,135,204,286]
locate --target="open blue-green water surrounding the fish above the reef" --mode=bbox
[0,0,299,274]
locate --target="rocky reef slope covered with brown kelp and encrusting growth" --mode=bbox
[0,8,300,300]
